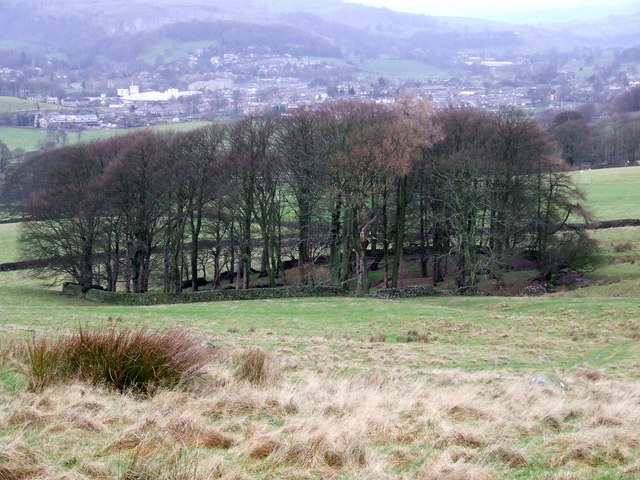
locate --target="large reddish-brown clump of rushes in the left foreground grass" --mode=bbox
[27,327,209,394]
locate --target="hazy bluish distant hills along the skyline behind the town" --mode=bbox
[0,0,640,68]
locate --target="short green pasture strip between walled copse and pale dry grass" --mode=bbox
[0,266,640,378]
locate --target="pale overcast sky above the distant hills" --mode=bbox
[346,0,640,19]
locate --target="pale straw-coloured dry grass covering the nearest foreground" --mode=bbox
[0,333,640,480]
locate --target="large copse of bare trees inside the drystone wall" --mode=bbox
[5,96,595,294]
